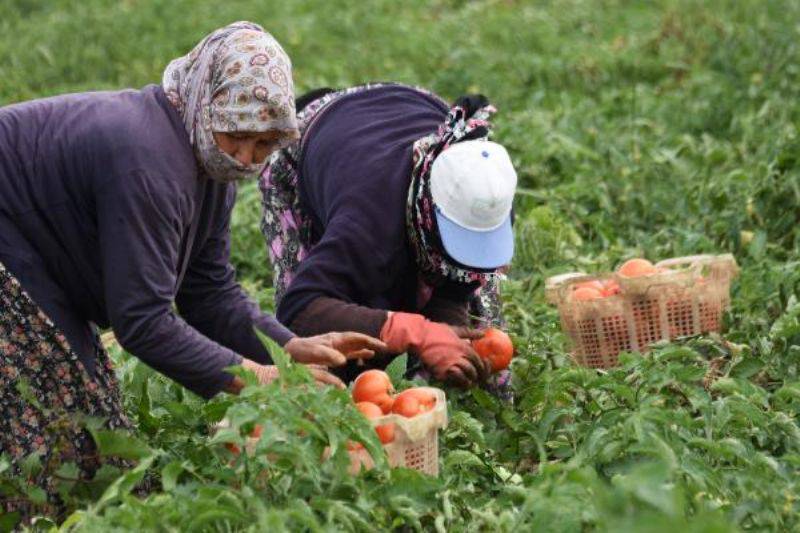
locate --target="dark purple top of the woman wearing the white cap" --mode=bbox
[277,86,447,329]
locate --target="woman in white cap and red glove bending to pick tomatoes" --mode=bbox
[260,84,517,385]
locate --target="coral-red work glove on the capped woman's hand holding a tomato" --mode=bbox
[381,313,485,385]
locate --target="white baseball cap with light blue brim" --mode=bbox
[431,140,517,269]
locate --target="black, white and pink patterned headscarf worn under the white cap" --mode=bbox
[406,95,502,285]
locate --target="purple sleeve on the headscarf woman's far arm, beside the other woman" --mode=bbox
[175,187,294,364]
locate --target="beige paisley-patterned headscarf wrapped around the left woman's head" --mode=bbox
[162,22,299,182]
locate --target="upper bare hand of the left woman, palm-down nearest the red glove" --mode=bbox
[283,331,388,367]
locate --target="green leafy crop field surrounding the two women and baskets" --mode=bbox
[0,0,800,533]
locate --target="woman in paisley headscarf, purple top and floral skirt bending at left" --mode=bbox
[0,22,384,516]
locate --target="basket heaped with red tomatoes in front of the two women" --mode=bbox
[350,370,447,476]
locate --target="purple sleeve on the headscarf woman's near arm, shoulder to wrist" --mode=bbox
[97,171,241,398]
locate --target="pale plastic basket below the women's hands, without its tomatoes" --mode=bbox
[350,387,447,476]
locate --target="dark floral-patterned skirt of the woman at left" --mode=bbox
[0,263,130,519]
